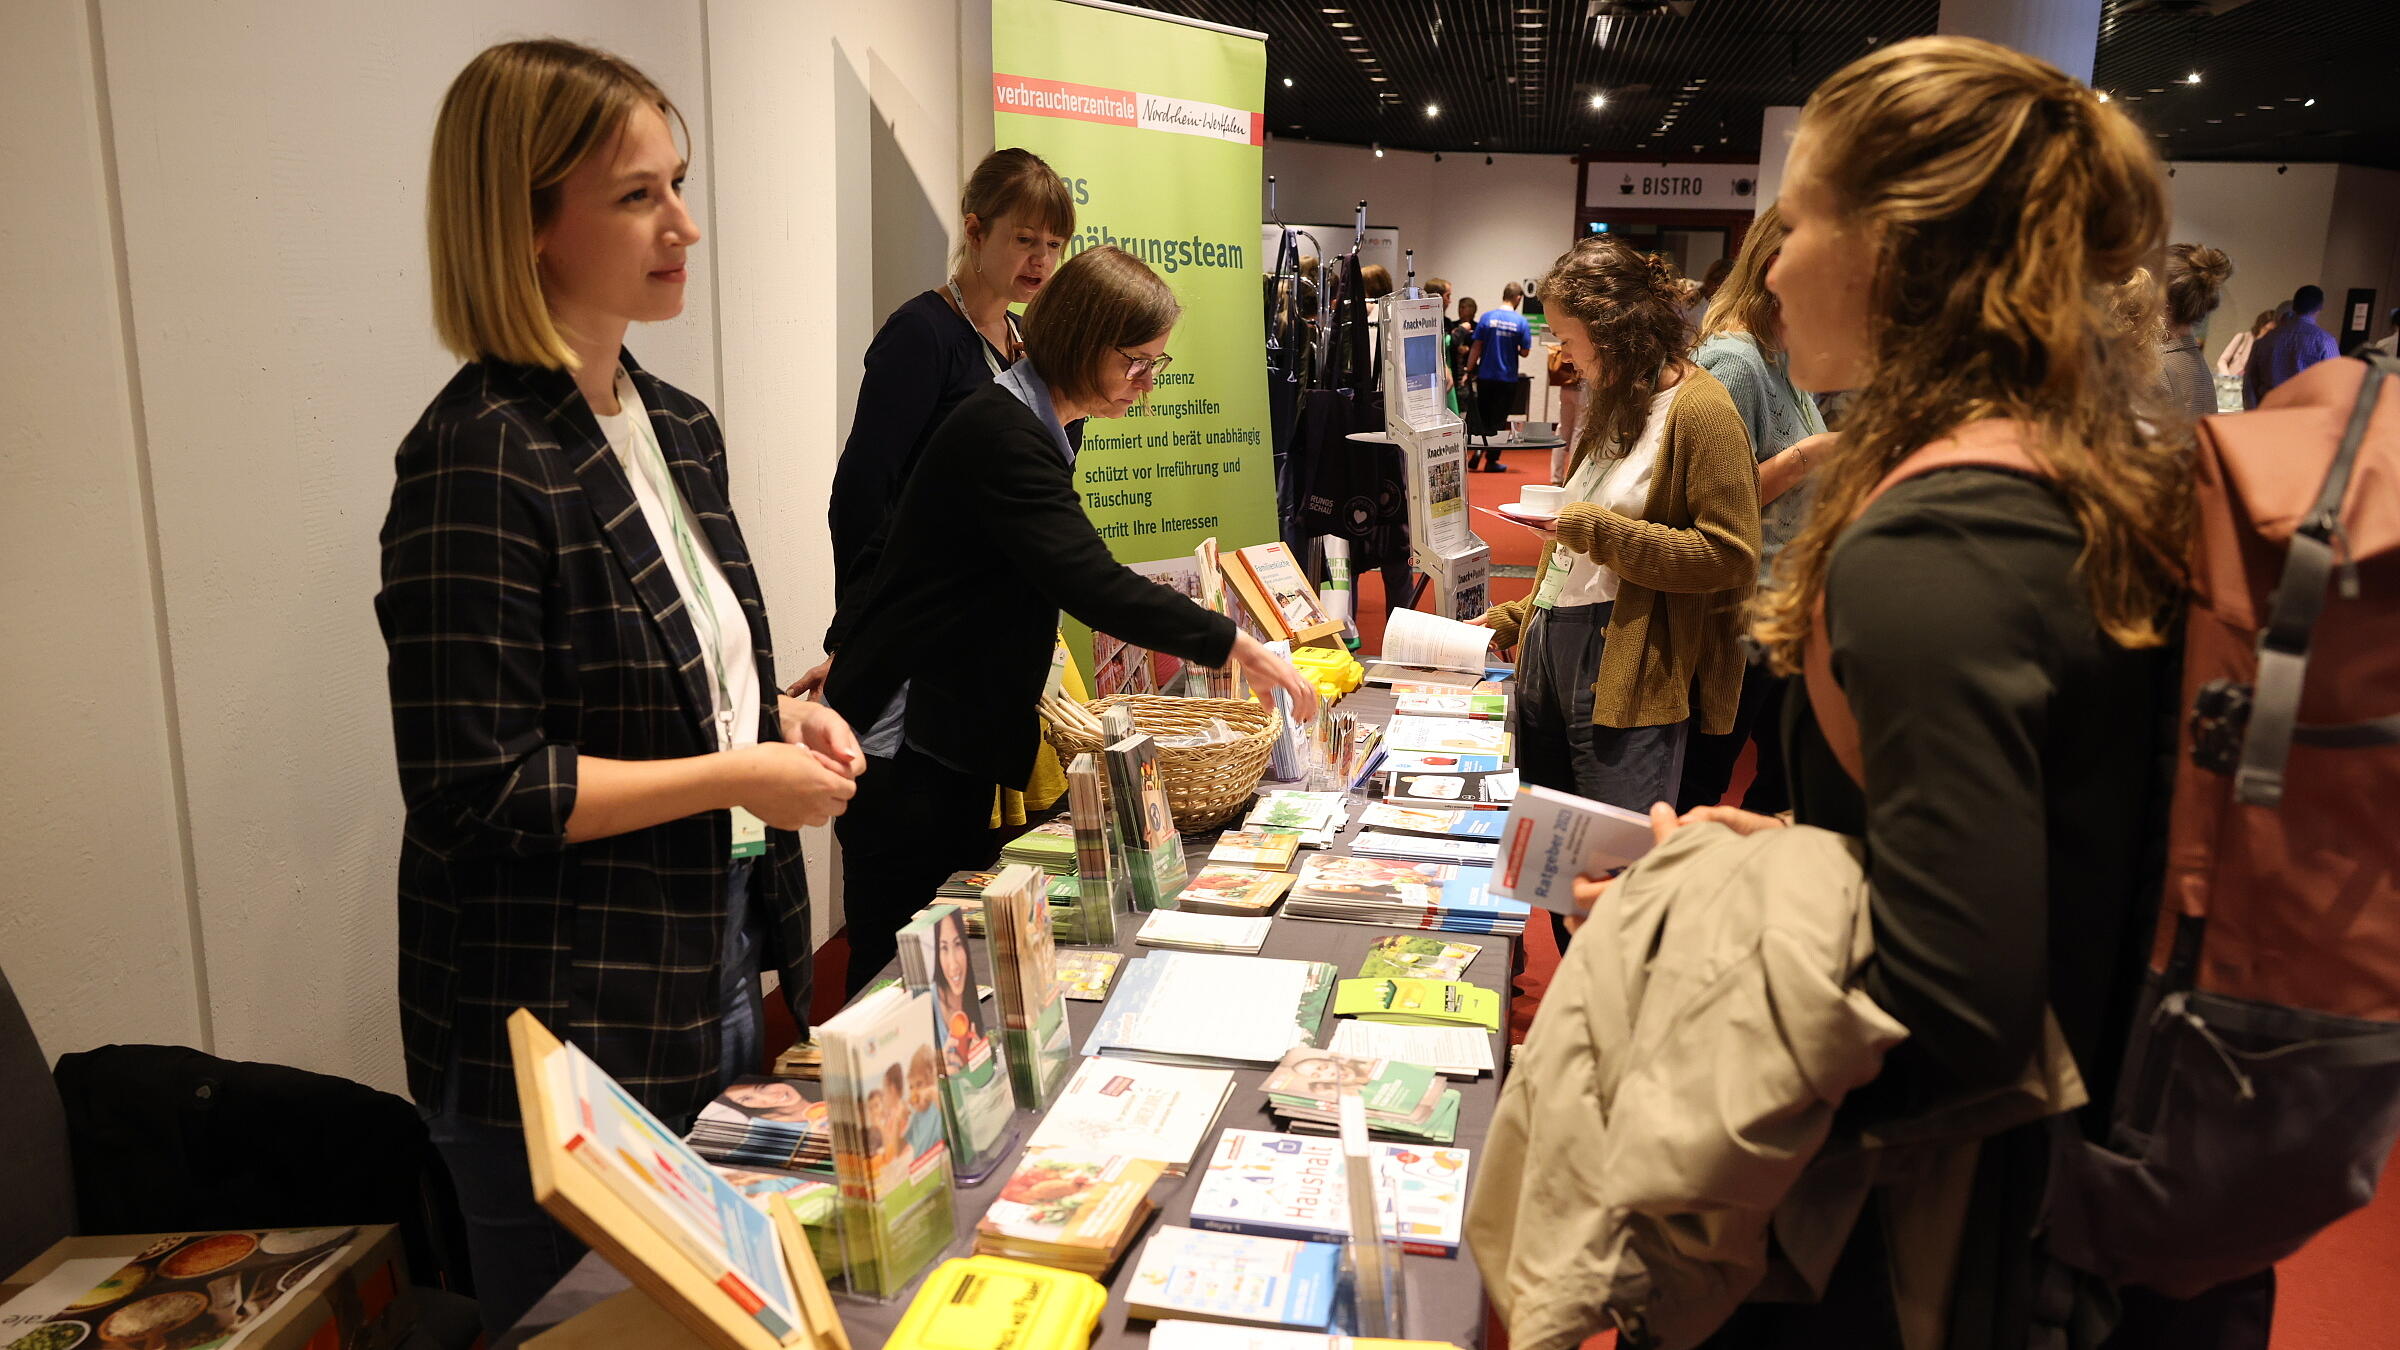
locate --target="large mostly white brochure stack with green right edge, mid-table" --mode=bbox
[1082,951,1337,1069]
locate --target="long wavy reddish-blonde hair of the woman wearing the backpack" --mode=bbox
[1752,36,2191,675]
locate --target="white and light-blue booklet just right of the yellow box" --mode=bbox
[1126,1227,1342,1326]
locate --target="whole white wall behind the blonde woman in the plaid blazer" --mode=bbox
[0,0,991,1088]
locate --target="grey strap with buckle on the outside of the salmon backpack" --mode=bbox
[2234,351,2400,807]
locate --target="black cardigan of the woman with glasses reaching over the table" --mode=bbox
[826,384,1234,783]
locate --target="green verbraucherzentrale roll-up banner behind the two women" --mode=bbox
[991,0,1274,670]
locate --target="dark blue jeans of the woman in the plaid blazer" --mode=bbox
[420,860,763,1340]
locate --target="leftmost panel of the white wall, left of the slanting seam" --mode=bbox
[0,0,209,1052]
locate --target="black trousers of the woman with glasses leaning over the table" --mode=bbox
[833,745,998,999]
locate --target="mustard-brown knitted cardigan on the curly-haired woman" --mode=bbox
[1483,368,1759,735]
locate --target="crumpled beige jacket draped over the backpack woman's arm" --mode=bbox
[1466,824,2083,1350]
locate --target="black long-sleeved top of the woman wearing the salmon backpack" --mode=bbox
[1786,468,2170,1117]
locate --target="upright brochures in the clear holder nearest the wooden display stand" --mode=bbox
[816,975,950,1297]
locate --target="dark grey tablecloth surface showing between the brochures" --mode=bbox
[494,687,1517,1350]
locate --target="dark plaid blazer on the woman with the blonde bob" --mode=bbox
[374,356,809,1124]
